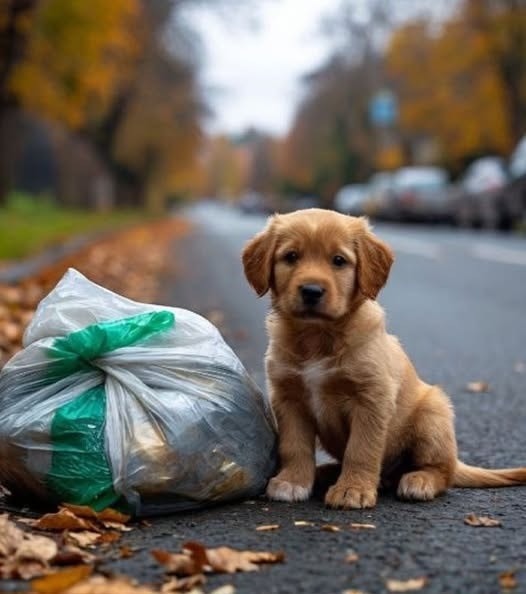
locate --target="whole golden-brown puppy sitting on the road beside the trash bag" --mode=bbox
[243,209,526,509]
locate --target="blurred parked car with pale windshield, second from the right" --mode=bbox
[449,156,508,229]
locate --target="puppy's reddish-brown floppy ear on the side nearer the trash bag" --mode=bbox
[242,218,276,297]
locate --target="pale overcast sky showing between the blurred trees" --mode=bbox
[187,0,339,134]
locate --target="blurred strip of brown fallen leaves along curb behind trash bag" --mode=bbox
[0,219,189,368]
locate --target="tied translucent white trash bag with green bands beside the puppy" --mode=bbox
[0,269,276,516]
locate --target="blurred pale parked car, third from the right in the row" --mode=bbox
[385,166,450,222]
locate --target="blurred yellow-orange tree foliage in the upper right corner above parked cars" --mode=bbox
[386,0,526,168]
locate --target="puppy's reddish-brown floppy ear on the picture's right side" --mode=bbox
[356,230,394,299]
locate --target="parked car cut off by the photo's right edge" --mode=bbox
[500,135,526,229]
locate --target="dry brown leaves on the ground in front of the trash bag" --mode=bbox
[0,505,284,594]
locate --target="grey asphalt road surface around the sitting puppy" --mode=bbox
[138,204,526,594]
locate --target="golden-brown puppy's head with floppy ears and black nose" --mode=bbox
[243,208,393,320]
